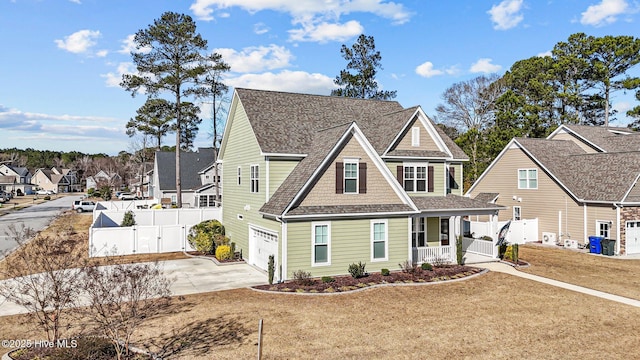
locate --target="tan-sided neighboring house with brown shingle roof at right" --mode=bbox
[468,125,640,254]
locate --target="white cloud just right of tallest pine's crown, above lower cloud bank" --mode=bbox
[213,44,293,73]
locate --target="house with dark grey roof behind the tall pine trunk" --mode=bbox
[149,148,222,207]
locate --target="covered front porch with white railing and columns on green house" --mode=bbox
[410,194,502,264]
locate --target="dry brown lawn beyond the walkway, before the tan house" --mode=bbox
[519,245,640,300]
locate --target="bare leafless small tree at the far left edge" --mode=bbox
[0,225,81,343]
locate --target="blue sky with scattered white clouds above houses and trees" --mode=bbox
[0,0,640,155]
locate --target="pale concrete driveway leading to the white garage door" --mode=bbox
[0,258,268,316]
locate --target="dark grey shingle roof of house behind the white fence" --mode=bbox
[156,148,213,191]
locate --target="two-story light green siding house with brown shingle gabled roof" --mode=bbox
[219,88,502,280]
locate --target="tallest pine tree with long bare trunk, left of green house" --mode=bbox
[120,12,207,207]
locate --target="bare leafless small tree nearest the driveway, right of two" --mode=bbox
[82,263,171,359]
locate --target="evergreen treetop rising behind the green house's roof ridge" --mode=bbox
[331,34,396,100]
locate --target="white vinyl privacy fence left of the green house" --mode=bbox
[89,208,222,257]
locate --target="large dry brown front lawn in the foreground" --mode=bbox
[0,273,640,359]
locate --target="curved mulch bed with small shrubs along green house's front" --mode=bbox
[253,265,482,293]
